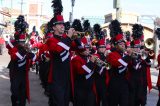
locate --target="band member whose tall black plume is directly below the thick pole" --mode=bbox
[107,20,131,106]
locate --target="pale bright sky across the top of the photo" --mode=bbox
[0,0,160,21]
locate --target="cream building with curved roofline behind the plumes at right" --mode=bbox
[102,12,154,40]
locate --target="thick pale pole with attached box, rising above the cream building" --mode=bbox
[113,0,122,21]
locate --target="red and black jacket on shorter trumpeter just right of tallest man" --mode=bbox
[71,55,96,97]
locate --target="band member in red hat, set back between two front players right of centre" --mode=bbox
[95,39,109,106]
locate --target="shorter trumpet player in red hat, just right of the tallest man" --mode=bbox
[71,37,96,106]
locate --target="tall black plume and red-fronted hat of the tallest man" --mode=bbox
[50,0,64,26]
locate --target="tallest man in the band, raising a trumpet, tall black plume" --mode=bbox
[46,0,84,106]
